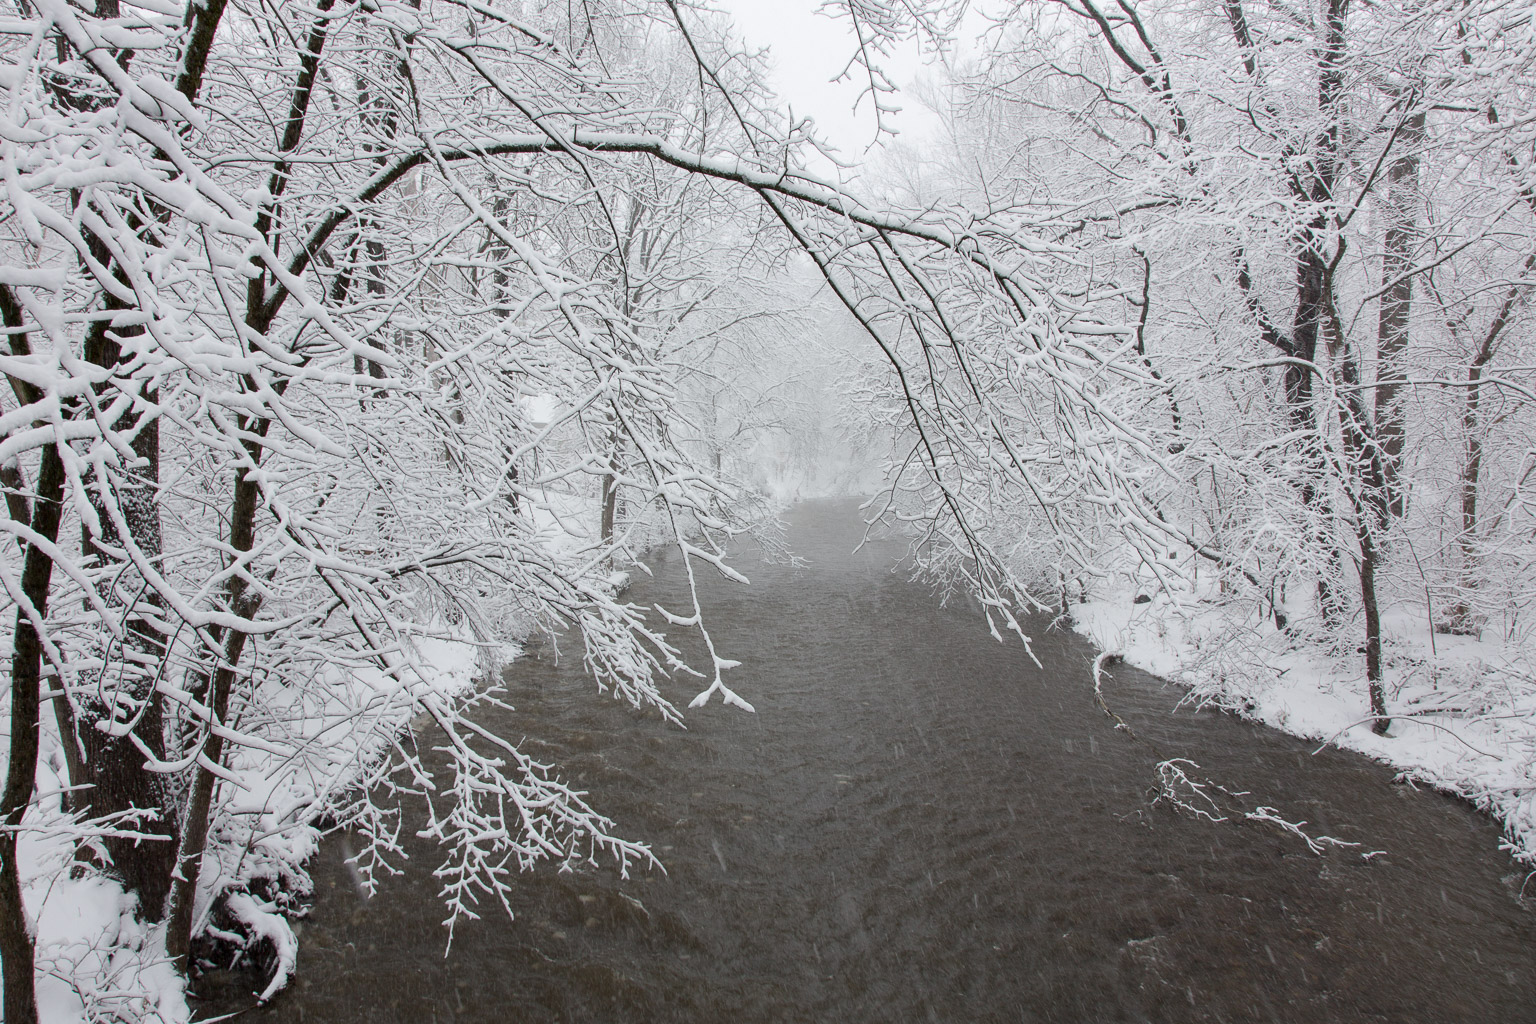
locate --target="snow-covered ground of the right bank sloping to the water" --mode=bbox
[1071,580,1536,864]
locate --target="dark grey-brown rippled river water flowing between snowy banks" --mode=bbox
[195,502,1536,1024]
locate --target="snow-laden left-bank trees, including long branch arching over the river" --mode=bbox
[0,0,1178,1022]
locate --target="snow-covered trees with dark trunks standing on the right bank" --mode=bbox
[921,0,1536,729]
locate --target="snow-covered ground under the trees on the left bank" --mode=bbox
[10,637,491,1024]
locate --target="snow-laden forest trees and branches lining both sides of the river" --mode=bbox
[0,0,1536,1024]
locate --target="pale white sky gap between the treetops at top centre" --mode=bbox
[717,0,937,170]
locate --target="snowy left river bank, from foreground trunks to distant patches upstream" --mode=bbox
[0,482,648,1024]
